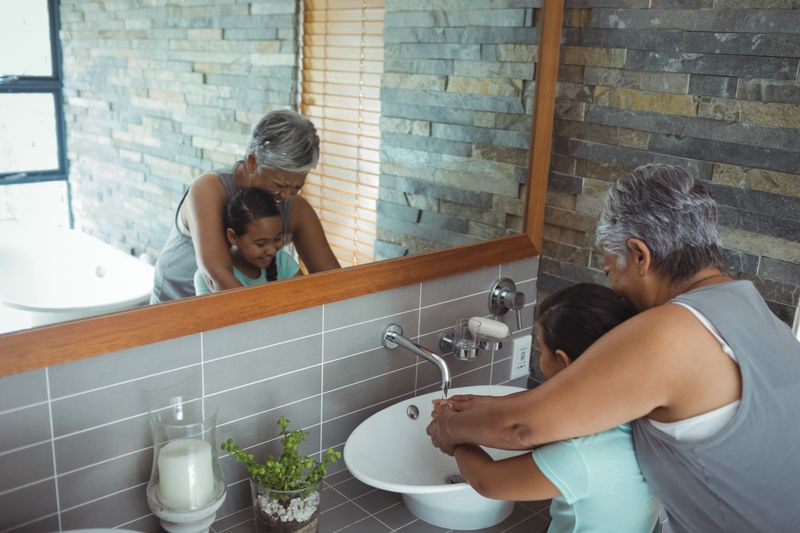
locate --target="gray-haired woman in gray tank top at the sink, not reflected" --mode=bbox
[428,165,800,533]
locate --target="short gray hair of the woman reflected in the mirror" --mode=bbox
[247,109,319,174]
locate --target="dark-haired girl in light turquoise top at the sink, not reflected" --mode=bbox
[446,283,660,533]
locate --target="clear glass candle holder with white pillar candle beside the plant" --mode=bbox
[147,397,225,531]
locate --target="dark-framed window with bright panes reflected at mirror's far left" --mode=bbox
[0,0,66,184]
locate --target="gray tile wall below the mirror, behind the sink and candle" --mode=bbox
[0,258,539,533]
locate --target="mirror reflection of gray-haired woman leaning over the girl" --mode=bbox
[150,110,339,303]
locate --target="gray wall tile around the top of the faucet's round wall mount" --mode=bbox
[324,310,419,362]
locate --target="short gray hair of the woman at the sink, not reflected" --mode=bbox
[597,165,723,281]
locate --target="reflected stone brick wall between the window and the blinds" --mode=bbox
[60,0,297,256]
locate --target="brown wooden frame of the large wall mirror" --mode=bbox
[0,0,564,376]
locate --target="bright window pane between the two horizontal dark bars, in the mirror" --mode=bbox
[0,93,58,173]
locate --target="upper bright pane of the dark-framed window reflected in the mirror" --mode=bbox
[0,0,53,76]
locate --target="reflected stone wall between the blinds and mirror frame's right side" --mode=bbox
[375,0,541,259]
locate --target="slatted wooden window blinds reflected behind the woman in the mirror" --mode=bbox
[301,0,384,266]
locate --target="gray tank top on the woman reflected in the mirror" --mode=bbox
[150,167,293,304]
